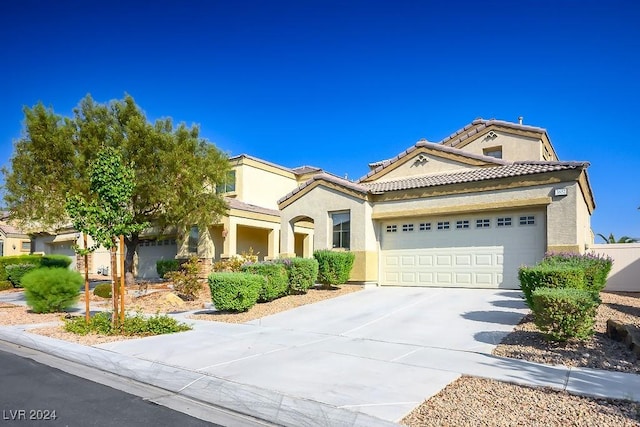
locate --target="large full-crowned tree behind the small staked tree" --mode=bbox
[2,95,229,280]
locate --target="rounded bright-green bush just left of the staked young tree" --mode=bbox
[22,267,84,313]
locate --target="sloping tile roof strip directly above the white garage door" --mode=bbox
[360,161,589,193]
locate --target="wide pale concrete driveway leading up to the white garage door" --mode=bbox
[98,288,526,421]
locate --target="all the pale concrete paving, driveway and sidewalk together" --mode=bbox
[0,288,640,426]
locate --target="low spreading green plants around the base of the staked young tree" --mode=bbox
[64,312,191,336]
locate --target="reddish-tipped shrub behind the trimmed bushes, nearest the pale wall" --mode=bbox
[541,253,613,294]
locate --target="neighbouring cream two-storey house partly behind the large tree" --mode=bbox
[136,154,320,279]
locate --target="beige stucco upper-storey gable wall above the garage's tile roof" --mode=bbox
[457,131,543,161]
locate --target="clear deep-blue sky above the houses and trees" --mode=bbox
[0,0,640,241]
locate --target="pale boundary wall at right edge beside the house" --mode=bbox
[589,243,640,292]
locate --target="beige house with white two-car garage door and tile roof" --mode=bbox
[278,119,595,289]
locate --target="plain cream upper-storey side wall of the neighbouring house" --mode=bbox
[235,164,298,210]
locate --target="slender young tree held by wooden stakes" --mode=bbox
[65,147,148,324]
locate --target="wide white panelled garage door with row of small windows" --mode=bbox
[380,211,546,289]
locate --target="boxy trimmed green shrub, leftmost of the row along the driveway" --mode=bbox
[208,273,266,311]
